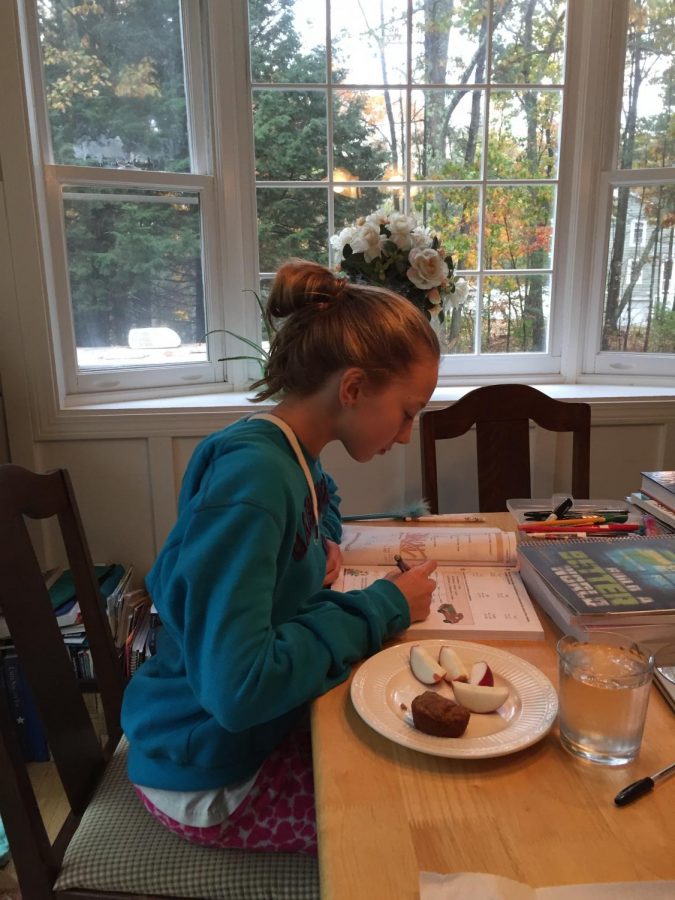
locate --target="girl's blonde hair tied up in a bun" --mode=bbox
[253,259,440,400]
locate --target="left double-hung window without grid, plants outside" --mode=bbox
[26,0,232,392]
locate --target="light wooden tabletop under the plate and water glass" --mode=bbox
[312,513,675,900]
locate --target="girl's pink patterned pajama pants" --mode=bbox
[136,726,317,856]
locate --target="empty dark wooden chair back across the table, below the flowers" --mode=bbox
[420,384,591,513]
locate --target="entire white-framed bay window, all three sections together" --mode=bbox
[15,0,675,396]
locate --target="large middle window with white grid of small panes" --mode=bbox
[249,0,566,374]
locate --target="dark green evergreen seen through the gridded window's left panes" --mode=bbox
[249,0,389,272]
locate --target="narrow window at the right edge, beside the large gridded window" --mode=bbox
[594,0,675,374]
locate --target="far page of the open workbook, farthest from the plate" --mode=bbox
[341,524,517,566]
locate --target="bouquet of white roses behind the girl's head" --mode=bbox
[331,209,455,322]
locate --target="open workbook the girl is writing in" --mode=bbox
[333,524,544,640]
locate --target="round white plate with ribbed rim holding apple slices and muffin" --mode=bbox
[351,640,558,759]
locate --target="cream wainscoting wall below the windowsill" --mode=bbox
[30,401,675,582]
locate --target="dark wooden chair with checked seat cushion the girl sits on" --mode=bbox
[0,465,319,900]
